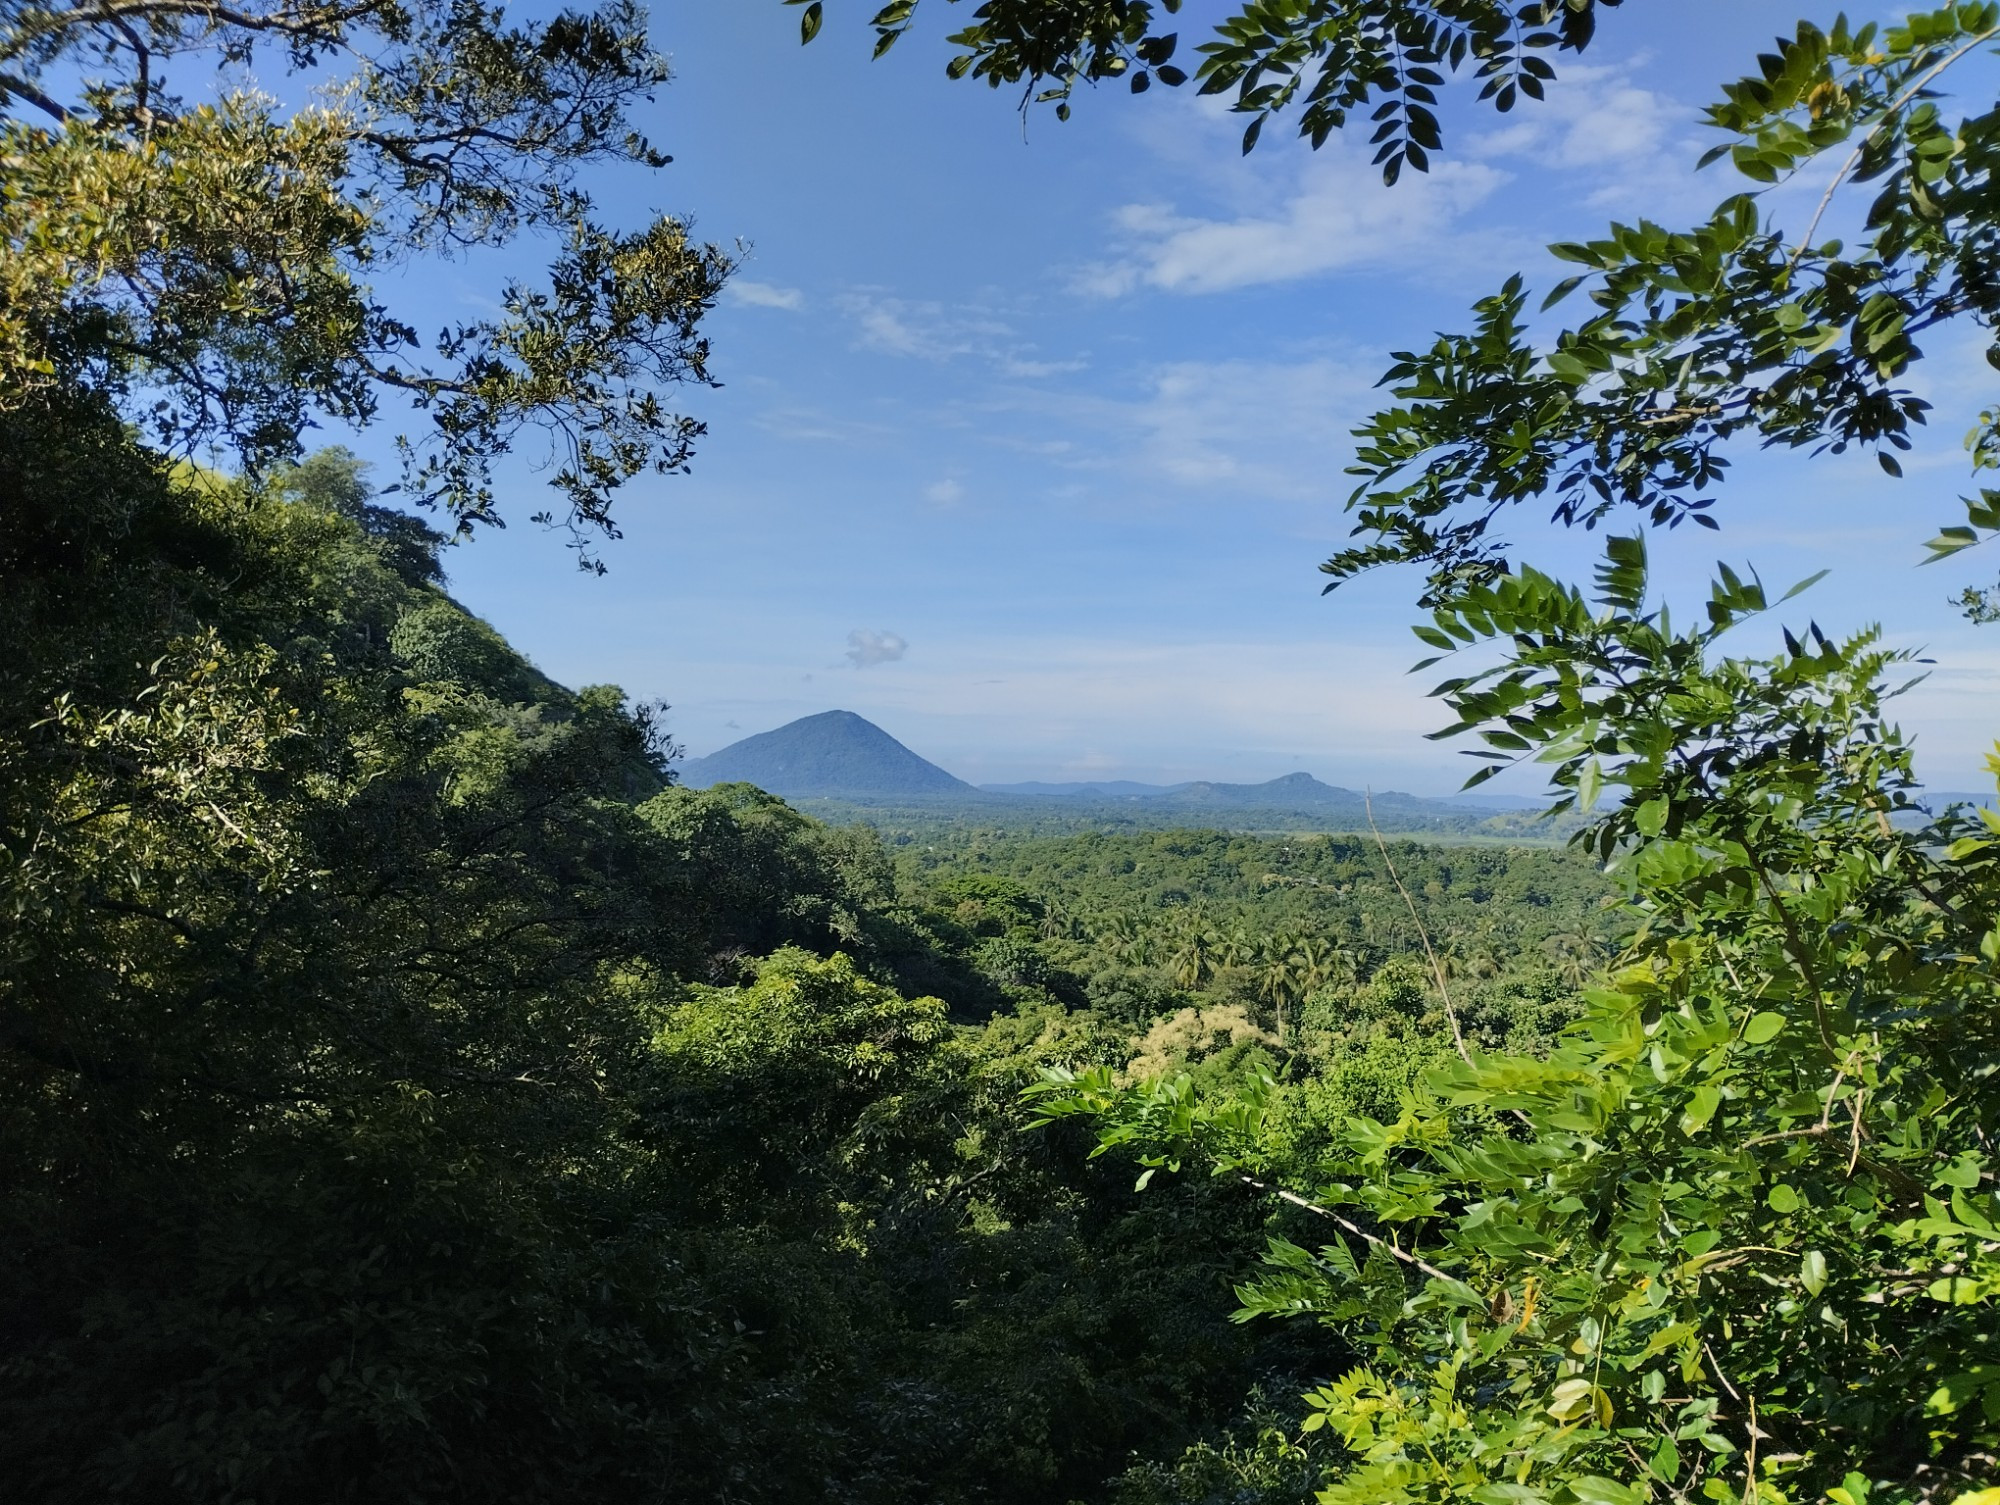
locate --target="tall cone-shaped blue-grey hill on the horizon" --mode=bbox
[680,710,978,799]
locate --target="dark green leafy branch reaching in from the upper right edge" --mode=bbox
[1322,4,2000,604]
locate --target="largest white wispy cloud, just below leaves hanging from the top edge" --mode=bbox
[1074,144,1506,298]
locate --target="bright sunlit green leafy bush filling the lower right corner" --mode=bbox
[1036,538,2000,1505]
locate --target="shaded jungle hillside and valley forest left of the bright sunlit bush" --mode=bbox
[0,430,1600,1501]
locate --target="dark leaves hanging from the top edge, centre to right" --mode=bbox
[786,0,1620,182]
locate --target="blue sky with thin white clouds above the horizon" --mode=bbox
[344,0,2000,793]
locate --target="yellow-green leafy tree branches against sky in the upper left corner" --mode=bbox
[0,0,730,540]
